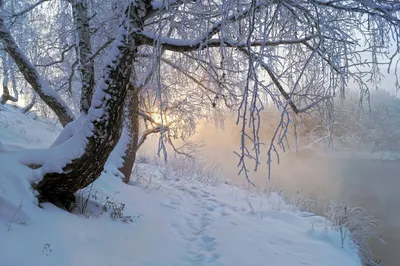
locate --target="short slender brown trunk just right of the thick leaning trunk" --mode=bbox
[119,88,139,183]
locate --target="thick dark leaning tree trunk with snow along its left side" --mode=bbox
[34,0,151,211]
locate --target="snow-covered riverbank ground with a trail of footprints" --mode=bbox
[0,106,361,266]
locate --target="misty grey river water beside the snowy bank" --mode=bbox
[258,156,400,266]
